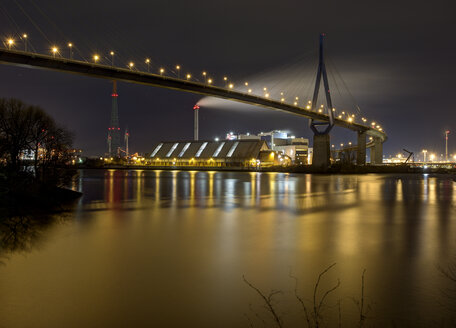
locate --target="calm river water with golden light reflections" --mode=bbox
[0,170,456,327]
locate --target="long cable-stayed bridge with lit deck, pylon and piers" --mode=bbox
[0,34,387,168]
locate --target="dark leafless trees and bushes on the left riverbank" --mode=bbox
[0,99,81,219]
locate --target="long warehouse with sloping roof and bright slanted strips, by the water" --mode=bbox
[146,140,281,168]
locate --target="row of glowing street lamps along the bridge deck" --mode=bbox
[6,34,383,131]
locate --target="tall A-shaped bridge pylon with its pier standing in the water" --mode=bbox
[309,33,334,170]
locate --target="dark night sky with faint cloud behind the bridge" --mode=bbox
[0,0,456,155]
